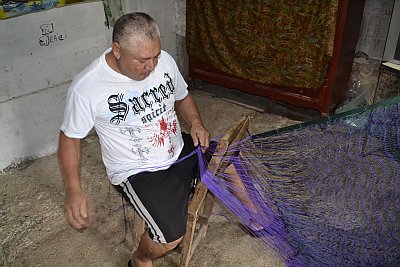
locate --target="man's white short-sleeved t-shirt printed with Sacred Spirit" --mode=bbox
[61,49,188,184]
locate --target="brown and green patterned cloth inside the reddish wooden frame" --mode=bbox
[186,0,339,89]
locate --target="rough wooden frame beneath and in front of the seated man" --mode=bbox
[133,116,250,267]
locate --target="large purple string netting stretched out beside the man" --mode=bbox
[200,98,400,266]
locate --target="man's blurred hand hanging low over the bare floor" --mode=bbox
[64,192,91,230]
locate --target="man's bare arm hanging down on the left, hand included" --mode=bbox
[58,131,90,229]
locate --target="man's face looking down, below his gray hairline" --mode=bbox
[112,38,161,81]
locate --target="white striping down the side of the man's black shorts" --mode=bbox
[122,180,167,244]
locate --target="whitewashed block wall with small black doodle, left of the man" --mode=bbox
[0,2,109,170]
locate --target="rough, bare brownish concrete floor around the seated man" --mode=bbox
[0,85,319,267]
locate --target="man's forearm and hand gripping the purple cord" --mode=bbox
[175,94,210,151]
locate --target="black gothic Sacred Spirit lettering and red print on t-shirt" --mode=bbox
[108,73,179,163]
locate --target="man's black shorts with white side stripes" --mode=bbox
[115,133,198,243]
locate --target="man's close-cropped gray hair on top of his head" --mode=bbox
[112,12,160,45]
